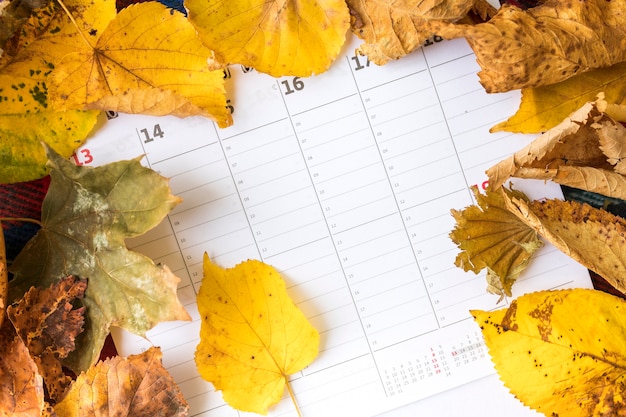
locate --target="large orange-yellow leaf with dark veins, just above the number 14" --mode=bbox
[14,0,232,127]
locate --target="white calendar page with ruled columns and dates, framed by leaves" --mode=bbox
[74,38,591,417]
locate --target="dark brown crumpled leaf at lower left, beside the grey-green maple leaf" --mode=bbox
[7,276,87,401]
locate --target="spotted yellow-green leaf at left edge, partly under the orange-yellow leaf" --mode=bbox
[0,2,100,183]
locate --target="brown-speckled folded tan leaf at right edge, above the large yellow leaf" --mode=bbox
[506,197,626,293]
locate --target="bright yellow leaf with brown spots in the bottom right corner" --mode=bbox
[471,289,626,417]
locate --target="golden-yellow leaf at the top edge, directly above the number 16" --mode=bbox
[185,0,350,77]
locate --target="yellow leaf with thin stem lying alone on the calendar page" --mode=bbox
[195,254,319,414]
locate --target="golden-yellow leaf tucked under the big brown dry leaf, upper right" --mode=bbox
[491,62,626,133]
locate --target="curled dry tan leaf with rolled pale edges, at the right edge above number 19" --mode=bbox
[487,99,626,199]
